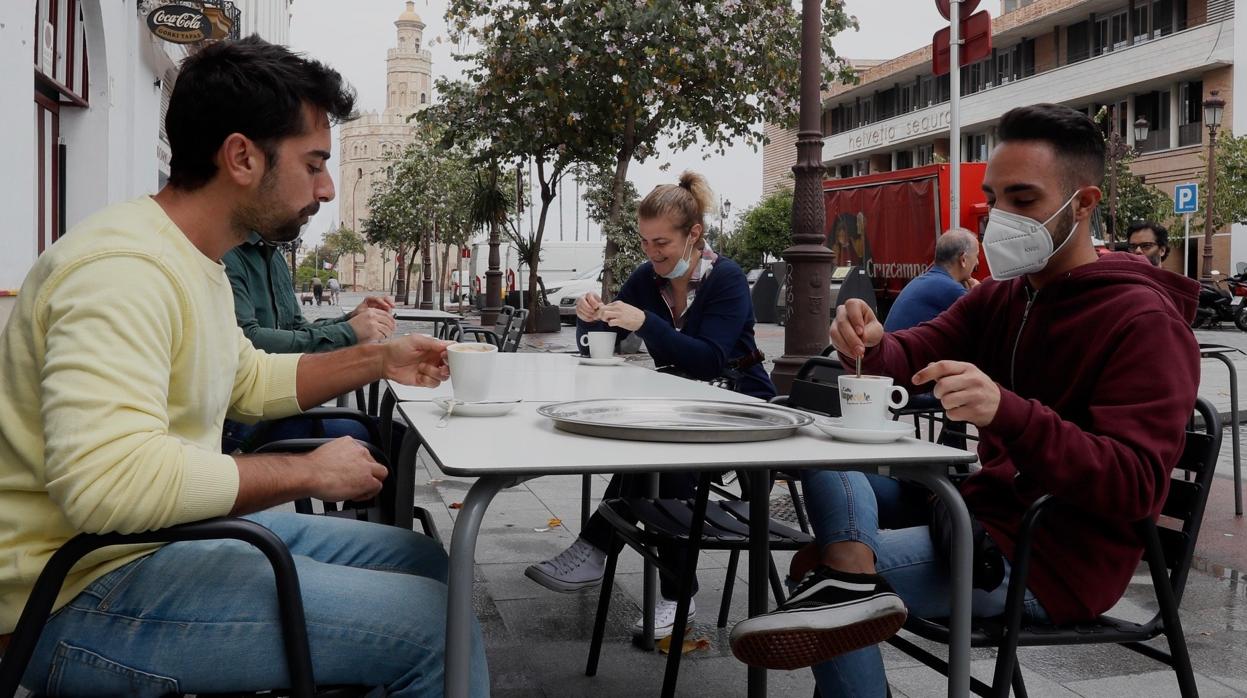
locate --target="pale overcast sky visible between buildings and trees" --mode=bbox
[291,0,957,246]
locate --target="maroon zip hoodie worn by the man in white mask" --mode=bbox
[862,253,1200,622]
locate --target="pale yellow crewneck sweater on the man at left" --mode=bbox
[0,197,299,633]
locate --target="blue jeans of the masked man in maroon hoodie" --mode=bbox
[802,470,1047,698]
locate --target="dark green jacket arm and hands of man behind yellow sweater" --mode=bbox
[223,233,394,354]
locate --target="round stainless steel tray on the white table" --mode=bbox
[537,398,814,444]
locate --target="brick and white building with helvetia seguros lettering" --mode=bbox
[763,0,1247,276]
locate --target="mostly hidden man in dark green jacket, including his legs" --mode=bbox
[221,233,394,452]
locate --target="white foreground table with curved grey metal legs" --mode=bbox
[398,363,975,698]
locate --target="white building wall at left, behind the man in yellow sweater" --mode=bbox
[0,0,291,323]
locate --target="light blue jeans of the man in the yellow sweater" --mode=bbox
[22,512,489,697]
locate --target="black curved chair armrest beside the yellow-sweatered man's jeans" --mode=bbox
[0,519,368,697]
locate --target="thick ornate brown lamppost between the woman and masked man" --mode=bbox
[771,0,832,395]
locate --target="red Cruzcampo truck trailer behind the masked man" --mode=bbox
[823,162,988,317]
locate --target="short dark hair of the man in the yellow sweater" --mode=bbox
[165,35,355,189]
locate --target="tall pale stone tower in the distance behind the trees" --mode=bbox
[338,1,433,290]
